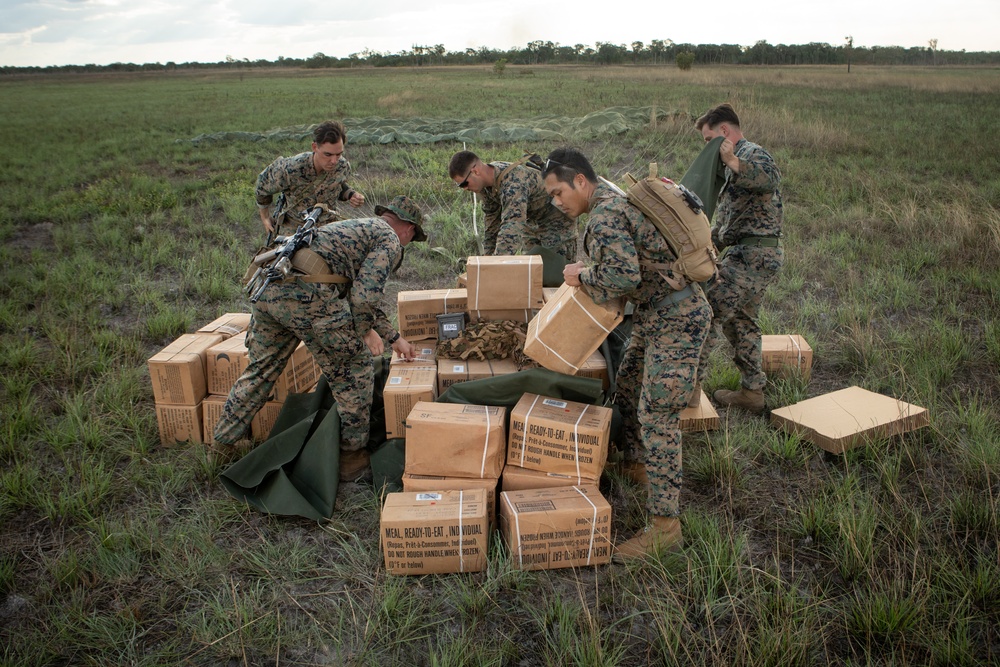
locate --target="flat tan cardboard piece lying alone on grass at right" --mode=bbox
[771,387,930,454]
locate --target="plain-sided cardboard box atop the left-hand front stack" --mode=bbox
[404,401,507,479]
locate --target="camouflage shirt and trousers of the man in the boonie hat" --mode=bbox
[215,218,403,450]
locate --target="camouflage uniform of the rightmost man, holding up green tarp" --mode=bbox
[698,139,785,390]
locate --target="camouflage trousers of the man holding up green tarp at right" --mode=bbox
[698,245,785,390]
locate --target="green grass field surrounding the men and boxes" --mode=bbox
[0,66,1000,666]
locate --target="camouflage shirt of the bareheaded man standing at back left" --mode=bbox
[255,152,362,235]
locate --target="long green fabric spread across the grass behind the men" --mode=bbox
[184,106,674,145]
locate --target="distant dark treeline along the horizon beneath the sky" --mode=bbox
[0,39,1000,74]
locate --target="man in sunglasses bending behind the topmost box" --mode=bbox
[449,151,578,262]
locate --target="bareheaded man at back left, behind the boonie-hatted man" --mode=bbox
[254,121,365,235]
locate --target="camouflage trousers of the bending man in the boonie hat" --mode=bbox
[215,282,374,450]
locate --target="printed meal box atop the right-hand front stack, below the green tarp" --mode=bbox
[507,394,611,481]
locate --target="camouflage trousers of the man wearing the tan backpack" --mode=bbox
[615,289,712,516]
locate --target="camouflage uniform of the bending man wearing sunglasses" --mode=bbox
[480,162,577,262]
